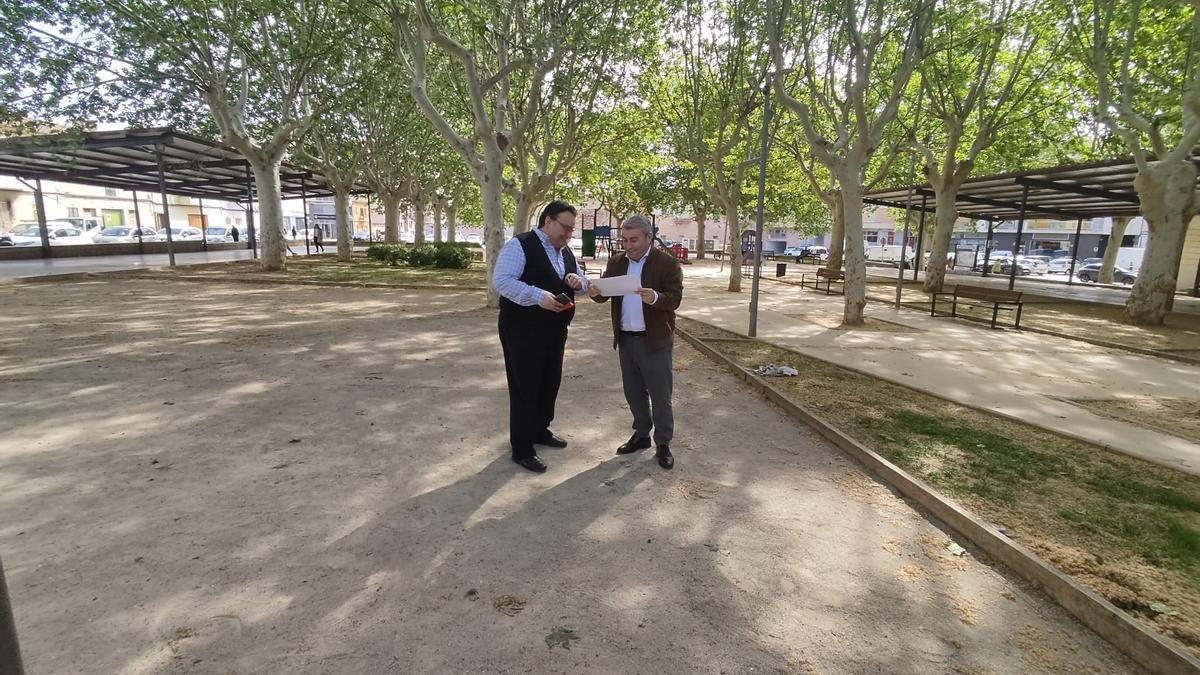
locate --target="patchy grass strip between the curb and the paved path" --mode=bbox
[679,318,1200,653]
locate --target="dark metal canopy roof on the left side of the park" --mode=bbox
[0,129,348,203]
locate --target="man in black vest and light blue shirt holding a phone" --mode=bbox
[492,202,587,473]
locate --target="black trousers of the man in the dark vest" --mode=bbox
[499,317,566,459]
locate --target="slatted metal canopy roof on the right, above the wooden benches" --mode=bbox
[863,151,1200,222]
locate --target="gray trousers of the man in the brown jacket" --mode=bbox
[617,333,674,446]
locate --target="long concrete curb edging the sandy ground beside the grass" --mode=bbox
[677,328,1200,675]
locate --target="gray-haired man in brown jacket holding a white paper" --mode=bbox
[588,215,683,468]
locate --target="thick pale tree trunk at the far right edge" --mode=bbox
[1110,161,1196,325]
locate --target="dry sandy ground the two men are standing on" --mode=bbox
[0,280,1136,675]
